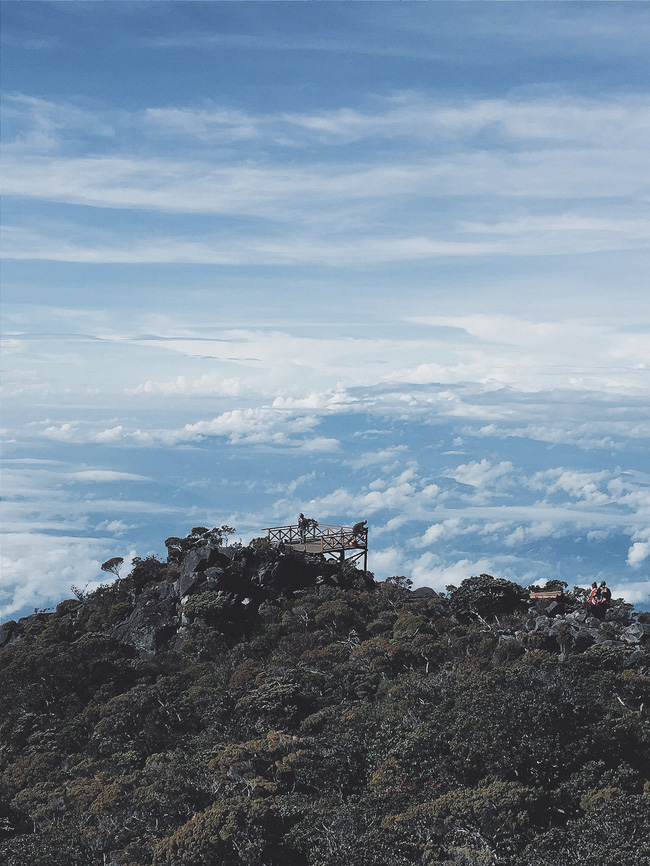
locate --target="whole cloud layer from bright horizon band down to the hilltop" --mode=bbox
[3,315,650,610]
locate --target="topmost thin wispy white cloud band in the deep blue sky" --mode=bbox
[3,88,650,151]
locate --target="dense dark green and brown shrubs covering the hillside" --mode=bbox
[0,530,650,866]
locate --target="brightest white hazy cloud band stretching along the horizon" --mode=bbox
[4,301,650,410]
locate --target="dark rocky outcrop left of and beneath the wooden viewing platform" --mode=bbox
[0,527,375,656]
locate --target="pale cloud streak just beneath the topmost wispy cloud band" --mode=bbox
[4,148,649,216]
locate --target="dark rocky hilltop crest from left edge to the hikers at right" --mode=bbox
[0,527,650,673]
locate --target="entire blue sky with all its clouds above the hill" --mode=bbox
[0,2,650,619]
